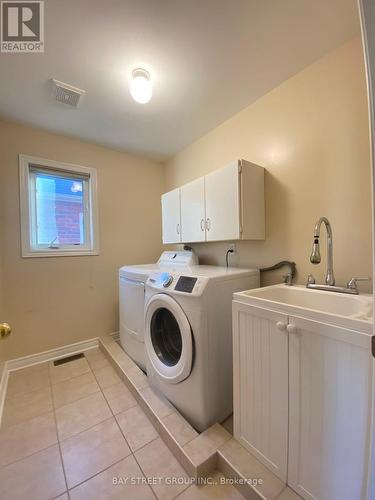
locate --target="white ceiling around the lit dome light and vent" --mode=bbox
[0,0,359,160]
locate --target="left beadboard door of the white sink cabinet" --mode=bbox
[233,301,288,482]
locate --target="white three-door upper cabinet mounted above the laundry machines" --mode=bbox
[162,160,265,243]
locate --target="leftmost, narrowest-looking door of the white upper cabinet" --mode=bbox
[161,189,181,243]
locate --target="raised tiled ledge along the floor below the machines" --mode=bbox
[99,336,300,500]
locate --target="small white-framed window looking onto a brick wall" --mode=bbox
[19,155,98,257]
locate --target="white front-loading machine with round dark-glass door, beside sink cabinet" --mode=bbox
[145,266,259,431]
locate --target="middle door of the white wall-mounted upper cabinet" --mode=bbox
[181,177,206,242]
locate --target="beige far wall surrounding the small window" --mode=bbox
[0,122,164,359]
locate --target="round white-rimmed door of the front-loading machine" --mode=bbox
[145,294,193,384]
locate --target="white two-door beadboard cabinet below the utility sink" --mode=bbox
[233,294,373,500]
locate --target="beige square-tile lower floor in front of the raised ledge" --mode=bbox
[0,349,243,500]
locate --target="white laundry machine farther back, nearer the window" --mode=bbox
[119,250,198,370]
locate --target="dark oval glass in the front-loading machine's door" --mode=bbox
[150,307,182,366]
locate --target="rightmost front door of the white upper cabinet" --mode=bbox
[205,161,241,241]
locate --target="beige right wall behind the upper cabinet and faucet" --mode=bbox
[165,39,372,290]
